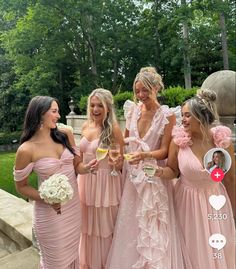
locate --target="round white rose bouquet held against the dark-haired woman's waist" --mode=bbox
[39,174,73,214]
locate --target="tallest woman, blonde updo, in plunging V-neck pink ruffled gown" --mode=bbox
[106,67,183,269]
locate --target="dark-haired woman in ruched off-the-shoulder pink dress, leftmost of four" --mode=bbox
[14,96,93,269]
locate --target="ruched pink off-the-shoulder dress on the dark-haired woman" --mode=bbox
[14,148,81,269]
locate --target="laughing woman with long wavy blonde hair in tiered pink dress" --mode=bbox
[78,88,123,269]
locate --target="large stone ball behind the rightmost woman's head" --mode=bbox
[201,70,236,116]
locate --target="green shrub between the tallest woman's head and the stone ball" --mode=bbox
[161,86,197,107]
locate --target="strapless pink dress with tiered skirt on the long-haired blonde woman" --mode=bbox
[78,137,122,269]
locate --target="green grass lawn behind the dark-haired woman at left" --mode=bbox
[0,152,37,197]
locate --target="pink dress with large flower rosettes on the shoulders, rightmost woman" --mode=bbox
[173,126,235,269]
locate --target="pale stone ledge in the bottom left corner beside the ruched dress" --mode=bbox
[0,189,39,269]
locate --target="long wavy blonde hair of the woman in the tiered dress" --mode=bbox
[87,88,117,144]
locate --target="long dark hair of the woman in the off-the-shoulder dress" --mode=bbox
[20,96,74,154]
